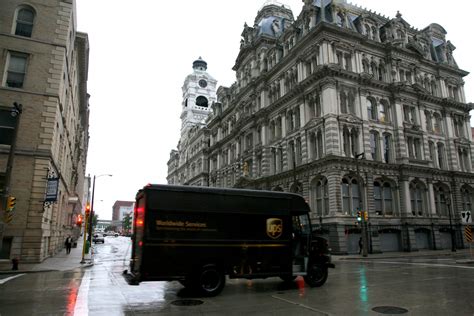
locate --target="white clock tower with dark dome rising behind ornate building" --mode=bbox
[181,57,217,141]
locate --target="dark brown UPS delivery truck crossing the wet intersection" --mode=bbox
[125,185,334,296]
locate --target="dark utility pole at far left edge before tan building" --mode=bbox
[0,102,23,250]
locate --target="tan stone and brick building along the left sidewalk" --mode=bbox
[0,0,89,262]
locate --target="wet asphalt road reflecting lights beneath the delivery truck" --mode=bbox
[0,237,474,316]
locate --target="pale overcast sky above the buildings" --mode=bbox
[76,0,474,219]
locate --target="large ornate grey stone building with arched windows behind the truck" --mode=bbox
[168,0,474,254]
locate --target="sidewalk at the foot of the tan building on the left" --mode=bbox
[0,237,94,274]
